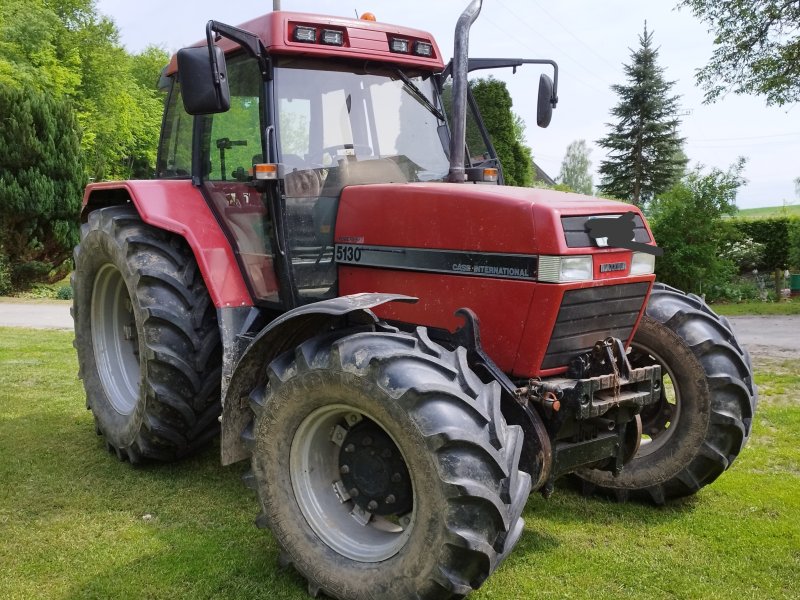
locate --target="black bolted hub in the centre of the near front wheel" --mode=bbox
[339,419,412,516]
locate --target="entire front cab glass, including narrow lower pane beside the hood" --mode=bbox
[274,59,449,302]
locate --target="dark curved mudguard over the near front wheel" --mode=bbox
[220,294,417,466]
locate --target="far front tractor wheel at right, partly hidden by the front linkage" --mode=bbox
[578,284,757,504]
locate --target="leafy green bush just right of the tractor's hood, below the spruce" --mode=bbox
[650,158,745,295]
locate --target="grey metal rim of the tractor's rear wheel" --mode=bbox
[91,264,141,415]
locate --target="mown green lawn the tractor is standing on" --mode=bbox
[0,329,800,600]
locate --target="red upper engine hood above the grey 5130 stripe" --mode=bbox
[335,178,652,255]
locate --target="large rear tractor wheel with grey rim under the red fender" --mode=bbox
[72,207,222,463]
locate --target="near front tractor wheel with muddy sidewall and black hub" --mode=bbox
[243,328,531,600]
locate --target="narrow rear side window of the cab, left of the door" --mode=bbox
[156,81,193,179]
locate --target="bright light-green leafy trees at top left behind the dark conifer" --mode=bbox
[0,0,168,179]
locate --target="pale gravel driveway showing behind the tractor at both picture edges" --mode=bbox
[0,302,800,358]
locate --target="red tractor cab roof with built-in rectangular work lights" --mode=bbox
[166,11,444,75]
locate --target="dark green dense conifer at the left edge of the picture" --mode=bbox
[0,85,86,291]
